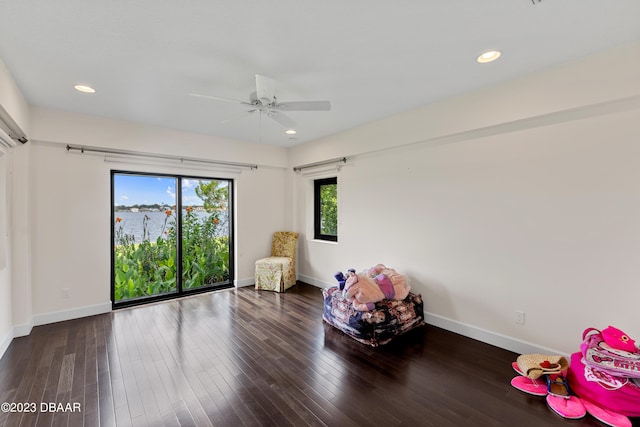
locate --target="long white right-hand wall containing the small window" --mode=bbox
[290,44,640,354]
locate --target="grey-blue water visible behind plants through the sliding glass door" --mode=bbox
[115,212,229,243]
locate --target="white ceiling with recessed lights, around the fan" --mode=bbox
[0,0,640,146]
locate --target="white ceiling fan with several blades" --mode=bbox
[189,74,331,129]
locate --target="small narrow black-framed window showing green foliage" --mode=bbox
[313,177,338,242]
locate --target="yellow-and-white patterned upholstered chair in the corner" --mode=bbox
[256,231,298,292]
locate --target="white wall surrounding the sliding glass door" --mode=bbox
[3,108,291,335]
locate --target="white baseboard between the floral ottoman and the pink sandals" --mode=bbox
[424,312,568,356]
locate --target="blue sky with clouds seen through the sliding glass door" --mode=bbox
[113,174,214,206]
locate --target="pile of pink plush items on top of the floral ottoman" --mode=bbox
[334,264,411,311]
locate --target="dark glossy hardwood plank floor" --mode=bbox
[0,283,636,427]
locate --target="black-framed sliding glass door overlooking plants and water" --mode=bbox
[111,171,233,307]
